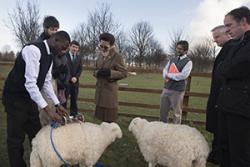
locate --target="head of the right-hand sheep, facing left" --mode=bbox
[128,117,148,135]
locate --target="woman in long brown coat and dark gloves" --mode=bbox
[94,33,127,122]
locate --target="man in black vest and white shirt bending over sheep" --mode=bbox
[3,31,70,167]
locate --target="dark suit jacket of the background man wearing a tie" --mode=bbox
[66,52,83,84]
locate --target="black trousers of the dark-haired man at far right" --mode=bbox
[219,111,250,167]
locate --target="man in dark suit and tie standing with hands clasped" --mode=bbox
[63,40,82,117]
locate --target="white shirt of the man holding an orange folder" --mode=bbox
[162,55,193,81]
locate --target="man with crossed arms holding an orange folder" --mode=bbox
[160,41,193,124]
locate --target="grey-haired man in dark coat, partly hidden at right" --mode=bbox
[206,25,232,164]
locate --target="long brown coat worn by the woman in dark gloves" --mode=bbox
[94,49,127,108]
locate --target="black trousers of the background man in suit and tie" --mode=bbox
[63,83,79,116]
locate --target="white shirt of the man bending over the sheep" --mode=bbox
[22,40,59,108]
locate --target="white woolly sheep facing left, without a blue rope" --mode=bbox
[128,117,209,167]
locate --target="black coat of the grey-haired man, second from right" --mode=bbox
[206,40,235,133]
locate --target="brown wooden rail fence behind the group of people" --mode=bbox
[0,62,211,124]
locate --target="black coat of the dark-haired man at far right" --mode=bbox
[217,31,250,118]
